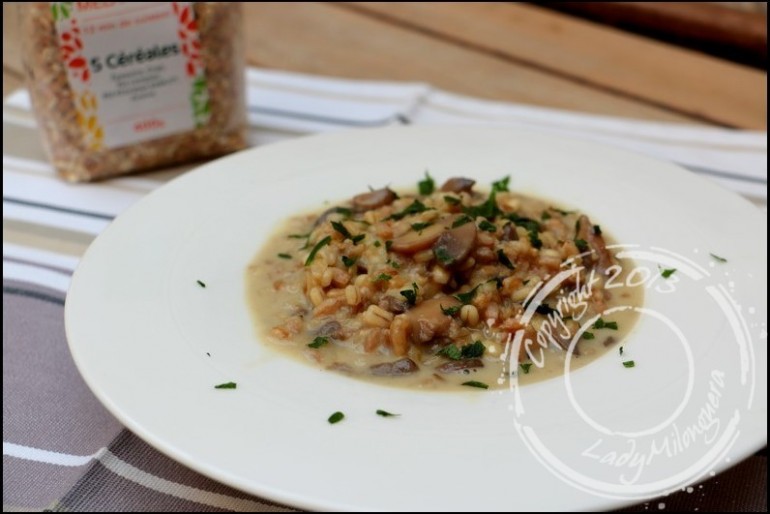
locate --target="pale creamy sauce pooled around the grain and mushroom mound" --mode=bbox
[246,188,643,391]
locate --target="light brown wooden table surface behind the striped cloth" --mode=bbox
[3,3,767,130]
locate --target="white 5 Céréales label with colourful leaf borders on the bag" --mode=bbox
[51,2,209,150]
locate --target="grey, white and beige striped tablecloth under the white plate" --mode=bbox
[3,69,767,511]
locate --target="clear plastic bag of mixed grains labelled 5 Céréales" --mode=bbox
[19,2,246,181]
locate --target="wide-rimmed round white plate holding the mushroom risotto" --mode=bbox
[66,128,767,510]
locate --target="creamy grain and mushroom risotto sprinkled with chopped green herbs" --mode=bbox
[246,174,642,390]
